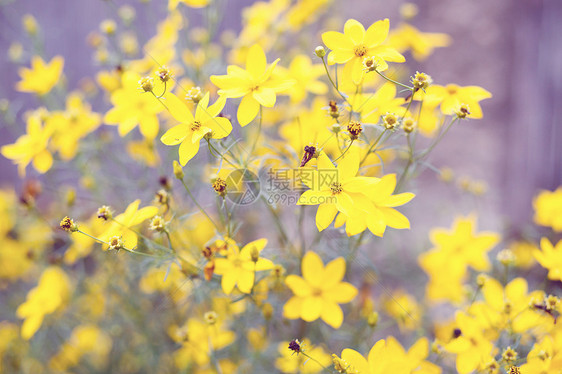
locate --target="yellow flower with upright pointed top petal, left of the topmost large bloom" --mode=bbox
[211,44,295,126]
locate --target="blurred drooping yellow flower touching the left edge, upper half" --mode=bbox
[1,109,53,176]
